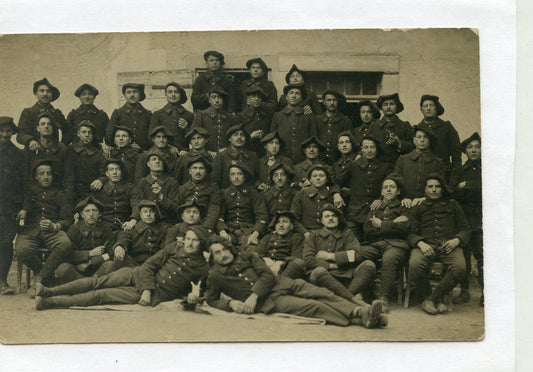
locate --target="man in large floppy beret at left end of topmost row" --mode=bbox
[17,78,70,151]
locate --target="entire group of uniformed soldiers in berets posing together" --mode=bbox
[0,51,483,328]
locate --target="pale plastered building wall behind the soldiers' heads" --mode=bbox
[0,29,480,142]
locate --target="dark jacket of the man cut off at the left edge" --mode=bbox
[0,142,26,217]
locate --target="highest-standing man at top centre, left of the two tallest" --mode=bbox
[191,50,238,113]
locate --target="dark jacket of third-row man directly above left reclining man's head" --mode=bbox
[176,181,220,230]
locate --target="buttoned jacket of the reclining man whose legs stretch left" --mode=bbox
[134,244,209,306]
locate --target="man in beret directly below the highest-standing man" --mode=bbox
[192,86,236,153]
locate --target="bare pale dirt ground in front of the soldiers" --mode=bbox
[0,264,484,344]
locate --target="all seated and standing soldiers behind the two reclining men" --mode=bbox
[0,52,482,325]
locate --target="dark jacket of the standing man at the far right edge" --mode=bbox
[450,160,483,231]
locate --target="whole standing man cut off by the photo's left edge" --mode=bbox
[0,116,26,295]
